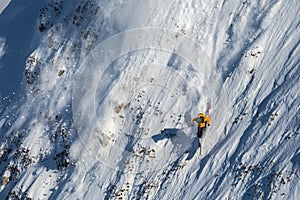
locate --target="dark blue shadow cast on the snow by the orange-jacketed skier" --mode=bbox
[152,128,199,160]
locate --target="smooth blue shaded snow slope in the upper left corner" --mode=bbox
[0,0,41,111]
